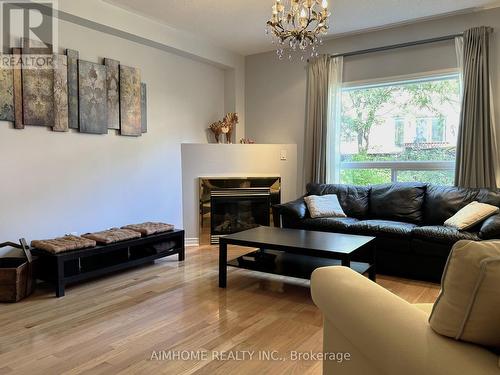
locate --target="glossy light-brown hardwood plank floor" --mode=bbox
[0,247,439,375]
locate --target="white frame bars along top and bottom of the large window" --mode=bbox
[339,69,460,183]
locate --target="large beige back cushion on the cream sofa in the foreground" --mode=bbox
[429,241,500,350]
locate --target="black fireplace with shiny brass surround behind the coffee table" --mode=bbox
[199,177,281,245]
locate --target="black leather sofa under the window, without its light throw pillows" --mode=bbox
[273,183,500,282]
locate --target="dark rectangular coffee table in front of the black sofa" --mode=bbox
[219,227,376,288]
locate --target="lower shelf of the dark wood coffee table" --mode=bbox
[227,250,372,279]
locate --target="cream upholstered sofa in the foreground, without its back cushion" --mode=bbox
[311,267,500,375]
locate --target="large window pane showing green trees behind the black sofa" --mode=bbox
[340,75,460,185]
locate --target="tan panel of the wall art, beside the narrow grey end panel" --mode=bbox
[120,65,142,137]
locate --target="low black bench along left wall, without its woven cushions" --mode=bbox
[31,230,185,297]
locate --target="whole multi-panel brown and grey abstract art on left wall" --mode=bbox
[4,38,148,137]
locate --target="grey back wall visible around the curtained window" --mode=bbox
[245,8,500,191]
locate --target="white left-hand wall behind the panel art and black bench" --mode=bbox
[0,2,234,256]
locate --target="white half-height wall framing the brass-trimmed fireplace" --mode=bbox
[182,144,297,244]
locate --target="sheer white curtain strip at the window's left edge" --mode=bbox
[326,56,344,184]
